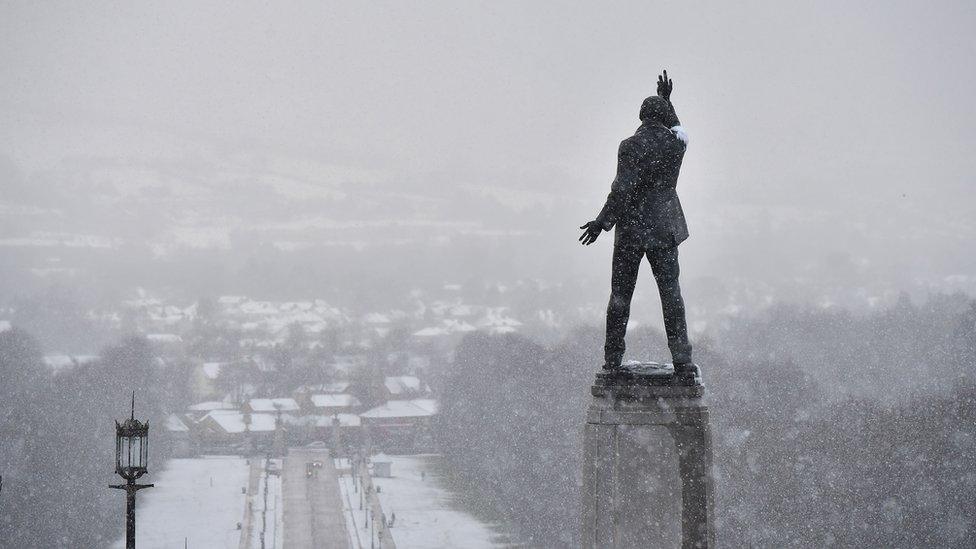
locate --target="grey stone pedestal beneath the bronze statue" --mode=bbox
[581,363,715,549]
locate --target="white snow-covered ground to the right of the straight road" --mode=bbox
[339,456,505,549]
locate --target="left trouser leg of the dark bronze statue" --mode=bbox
[604,243,644,368]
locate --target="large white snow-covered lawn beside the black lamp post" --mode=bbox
[113,456,248,549]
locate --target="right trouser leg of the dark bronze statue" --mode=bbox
[647,246,691,364]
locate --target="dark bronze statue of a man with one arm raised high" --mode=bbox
[579,71,697,380]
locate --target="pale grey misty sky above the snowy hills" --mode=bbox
[0,2,976,296]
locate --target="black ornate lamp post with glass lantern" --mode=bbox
[109,391,153,549]
